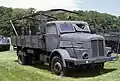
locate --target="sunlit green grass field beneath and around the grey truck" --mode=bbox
[0,51,120,81]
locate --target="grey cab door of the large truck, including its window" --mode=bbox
[45,23,58,51]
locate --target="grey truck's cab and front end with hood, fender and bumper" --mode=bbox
[46,21,118,72]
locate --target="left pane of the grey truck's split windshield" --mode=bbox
[59,23,75,33]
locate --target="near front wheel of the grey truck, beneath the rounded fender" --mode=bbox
[50,56,67,76]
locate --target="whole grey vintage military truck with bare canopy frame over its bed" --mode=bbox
[10,9,118,75]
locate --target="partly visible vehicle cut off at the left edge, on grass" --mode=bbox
[0,35,10,51]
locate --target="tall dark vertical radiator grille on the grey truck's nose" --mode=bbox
[91,40,104,57]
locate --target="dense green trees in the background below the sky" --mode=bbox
[0,6,120,36]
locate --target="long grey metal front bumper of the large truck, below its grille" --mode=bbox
[65,56,118,65]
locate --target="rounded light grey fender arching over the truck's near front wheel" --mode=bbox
[50,49,71,67]
